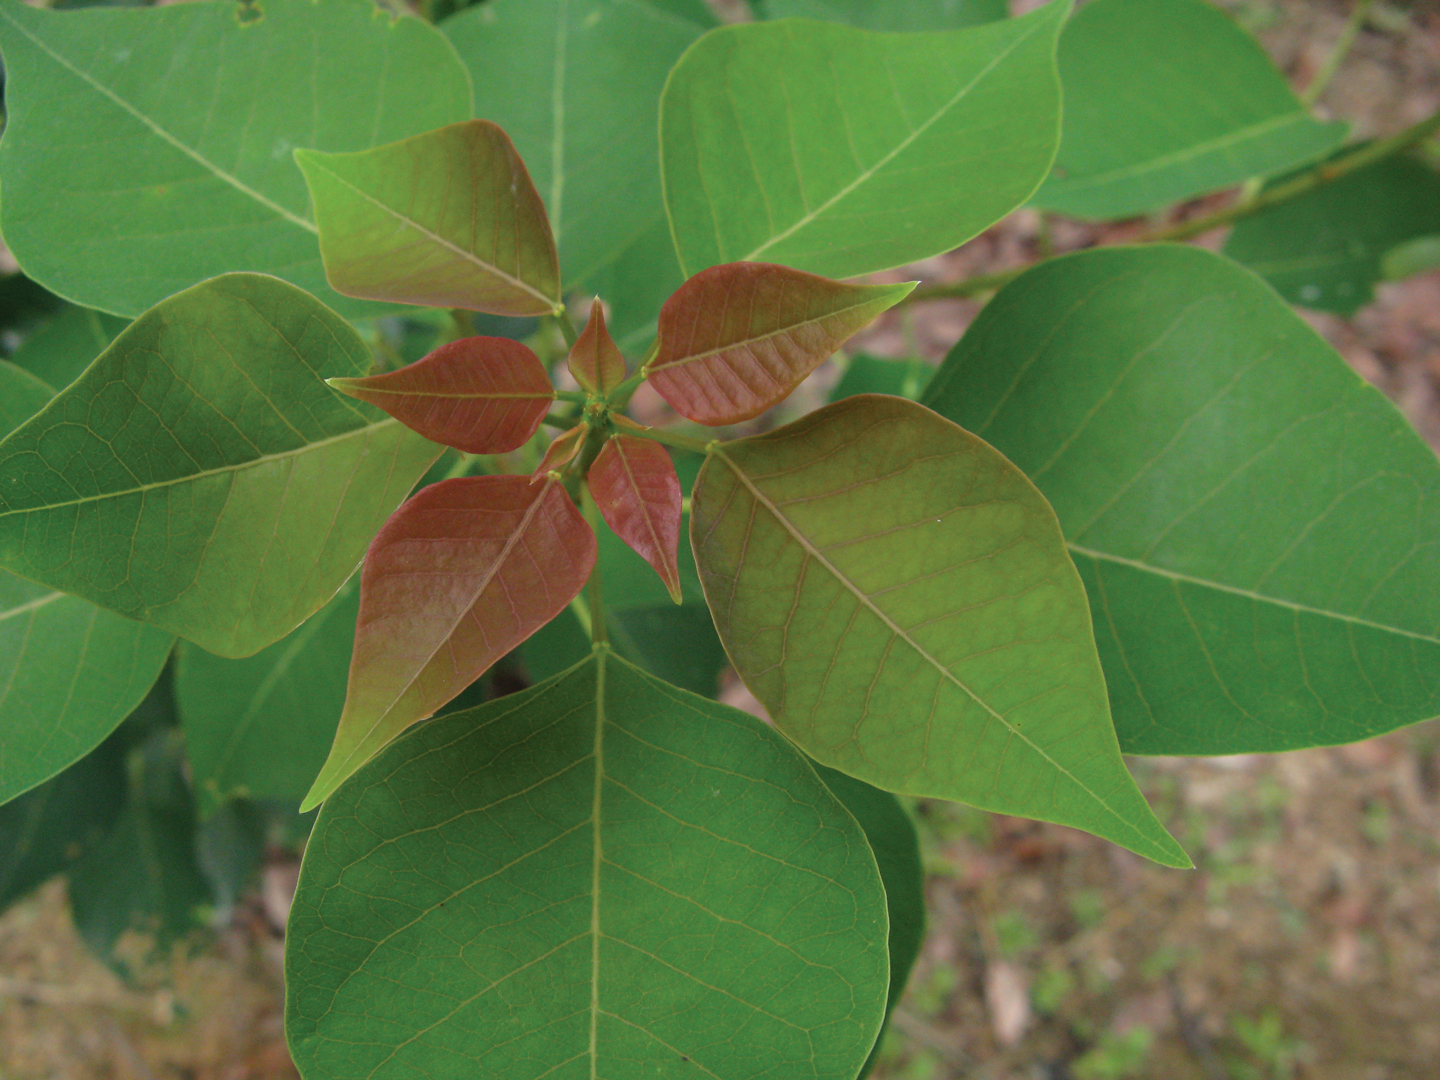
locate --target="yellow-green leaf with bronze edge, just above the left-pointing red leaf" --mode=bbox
[295,120,560,315]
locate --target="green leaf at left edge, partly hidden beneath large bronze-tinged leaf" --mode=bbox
[0,360,174,805]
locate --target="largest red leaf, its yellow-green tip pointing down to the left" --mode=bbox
[304,477,596,808]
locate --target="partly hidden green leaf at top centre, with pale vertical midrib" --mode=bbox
[441,0,714,328]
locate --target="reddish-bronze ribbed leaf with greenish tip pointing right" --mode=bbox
[647,262,914,425]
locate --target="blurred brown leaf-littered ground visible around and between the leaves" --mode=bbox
[0,0,1440,1080]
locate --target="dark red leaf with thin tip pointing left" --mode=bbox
[325,337,554,454]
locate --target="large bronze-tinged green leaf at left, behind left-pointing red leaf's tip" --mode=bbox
[0,274,439,657]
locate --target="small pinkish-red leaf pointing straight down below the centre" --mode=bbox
[586,435,681,603]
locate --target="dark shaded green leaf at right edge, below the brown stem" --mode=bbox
[1224,157,1440,315]
